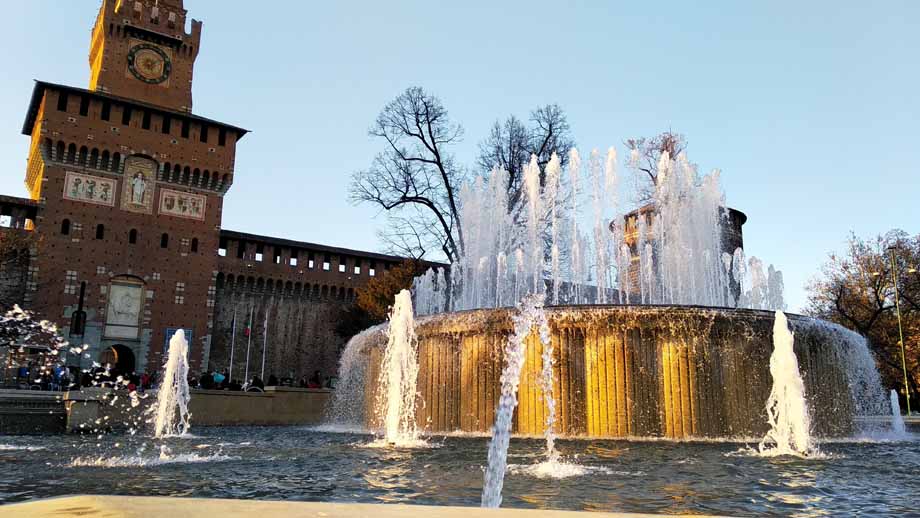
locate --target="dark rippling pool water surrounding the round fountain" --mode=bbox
[0,428,920,516]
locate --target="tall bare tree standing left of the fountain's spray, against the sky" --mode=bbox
[350,87,463,262]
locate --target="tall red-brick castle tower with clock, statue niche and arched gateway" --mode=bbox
[23,0,246,372]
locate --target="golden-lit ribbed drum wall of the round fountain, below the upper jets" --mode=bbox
[362,306,865,439]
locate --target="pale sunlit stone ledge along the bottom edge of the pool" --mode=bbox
[2,496,724,518]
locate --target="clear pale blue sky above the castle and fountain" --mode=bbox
[0,0,920,310]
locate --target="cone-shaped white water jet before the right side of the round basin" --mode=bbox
[759,311,817,456]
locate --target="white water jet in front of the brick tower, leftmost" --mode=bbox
[150,329,191,438]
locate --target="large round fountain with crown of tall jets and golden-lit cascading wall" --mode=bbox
[335,145,900,507]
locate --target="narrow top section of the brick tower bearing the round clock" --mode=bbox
[89,0,201,112]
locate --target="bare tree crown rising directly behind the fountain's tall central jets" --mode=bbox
[476,104,575,210]
